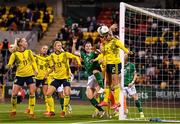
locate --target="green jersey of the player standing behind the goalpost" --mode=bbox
[124,62,136,87]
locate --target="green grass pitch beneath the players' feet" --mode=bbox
[0,104,180,124]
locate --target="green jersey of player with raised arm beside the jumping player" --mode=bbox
[80,51,100,76]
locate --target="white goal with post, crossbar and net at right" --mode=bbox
[119,3,180,121]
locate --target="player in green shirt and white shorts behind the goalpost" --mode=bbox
[124,55,144,118]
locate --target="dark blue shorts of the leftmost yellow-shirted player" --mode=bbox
[14,76,35,86]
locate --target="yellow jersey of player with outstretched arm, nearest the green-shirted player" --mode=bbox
[48,52,81,79]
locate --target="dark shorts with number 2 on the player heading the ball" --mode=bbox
[106,63,121,74]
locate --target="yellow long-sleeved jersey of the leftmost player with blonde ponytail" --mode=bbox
[8,49,38,77]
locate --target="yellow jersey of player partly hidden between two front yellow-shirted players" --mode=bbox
[35,55,49,80]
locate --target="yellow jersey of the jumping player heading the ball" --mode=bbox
[102,38,129,64]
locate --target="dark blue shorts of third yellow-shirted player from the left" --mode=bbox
[50,79,71,89]
